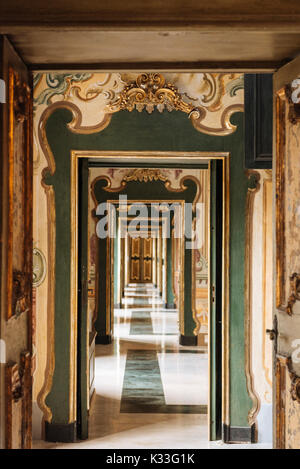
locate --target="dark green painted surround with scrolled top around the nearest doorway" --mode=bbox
[46,109,251,426]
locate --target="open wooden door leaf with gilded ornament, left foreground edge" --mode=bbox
[0,36,32,448]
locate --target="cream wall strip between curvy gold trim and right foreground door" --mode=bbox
[250,170,273,442]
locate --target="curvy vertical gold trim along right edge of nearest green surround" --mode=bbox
[245,170,260,426]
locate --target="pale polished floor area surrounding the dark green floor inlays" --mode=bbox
[33,288,271,449]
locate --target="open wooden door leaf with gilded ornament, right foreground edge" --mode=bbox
[274,58,300,449]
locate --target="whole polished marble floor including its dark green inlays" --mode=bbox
[34,289,272,449]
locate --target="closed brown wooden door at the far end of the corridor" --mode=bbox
[130,237,153,283]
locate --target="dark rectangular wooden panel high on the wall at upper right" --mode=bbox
[244,73,273,169]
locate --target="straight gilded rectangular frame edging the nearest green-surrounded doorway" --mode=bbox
[69,150,230,436]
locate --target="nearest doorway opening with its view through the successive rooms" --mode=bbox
[72,152,229,447]
